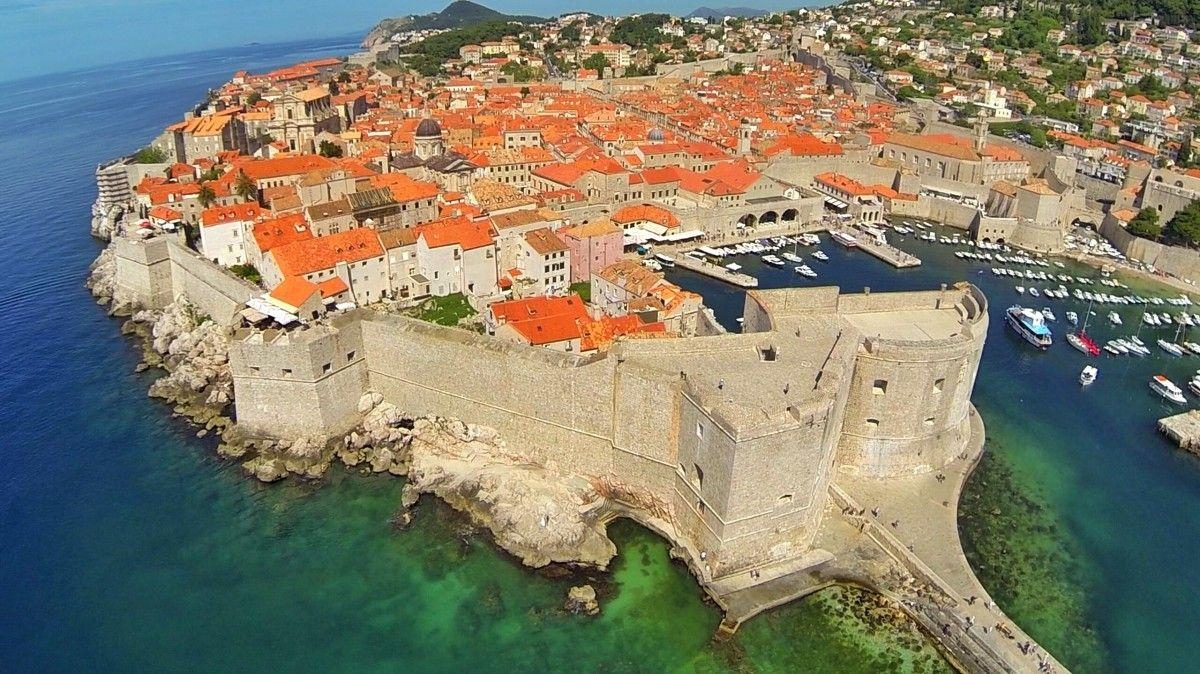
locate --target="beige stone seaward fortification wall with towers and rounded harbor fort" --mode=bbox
[118,239,988,582]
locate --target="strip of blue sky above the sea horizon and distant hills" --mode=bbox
[0,0,811,82]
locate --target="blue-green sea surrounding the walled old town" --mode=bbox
[0,32,1200,673]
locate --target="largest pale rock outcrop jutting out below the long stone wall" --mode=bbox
[404,419,617,568]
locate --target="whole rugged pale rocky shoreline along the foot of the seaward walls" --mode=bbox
[86,237,617,597]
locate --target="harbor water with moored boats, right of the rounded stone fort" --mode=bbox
[666,215,1200,672]
